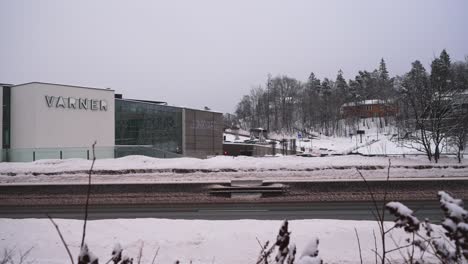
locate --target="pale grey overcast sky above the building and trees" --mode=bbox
[0,0,468,112]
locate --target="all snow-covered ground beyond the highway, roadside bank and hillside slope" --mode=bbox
[0,118,468,184]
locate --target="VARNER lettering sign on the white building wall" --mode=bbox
[45,95,107,111]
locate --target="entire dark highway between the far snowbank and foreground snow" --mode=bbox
[0,179,468,222]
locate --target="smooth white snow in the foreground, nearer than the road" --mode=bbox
[0,219,442,264]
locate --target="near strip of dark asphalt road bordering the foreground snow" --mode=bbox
[0,201,443,222]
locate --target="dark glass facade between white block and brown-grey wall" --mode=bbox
[115,99,182,153]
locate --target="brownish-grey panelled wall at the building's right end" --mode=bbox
[183,109,223,158]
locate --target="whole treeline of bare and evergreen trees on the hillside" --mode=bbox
[231,50,468,162]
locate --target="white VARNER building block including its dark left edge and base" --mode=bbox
[0,82,115,161]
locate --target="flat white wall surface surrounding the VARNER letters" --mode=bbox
[11,83,115,149]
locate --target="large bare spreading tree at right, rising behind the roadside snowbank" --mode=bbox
[401,50,462,163]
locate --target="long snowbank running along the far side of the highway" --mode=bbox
[0,155,468,184]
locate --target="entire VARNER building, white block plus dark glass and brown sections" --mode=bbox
[0,82,223,161]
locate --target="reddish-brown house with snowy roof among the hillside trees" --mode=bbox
[340,99,398,118]
